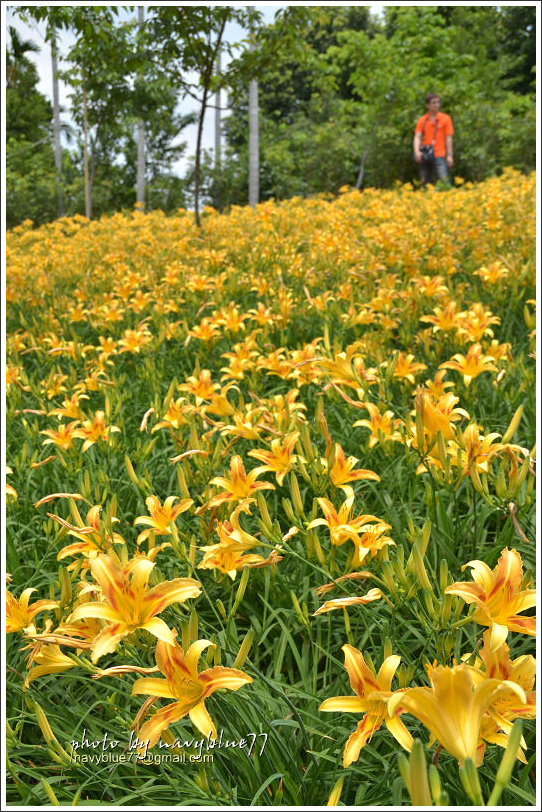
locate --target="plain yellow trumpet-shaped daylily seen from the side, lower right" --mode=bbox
[388,663,526,766]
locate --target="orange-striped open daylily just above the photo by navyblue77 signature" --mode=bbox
[132,640,252,749]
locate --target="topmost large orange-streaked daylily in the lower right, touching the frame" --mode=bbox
[444,548,536,648]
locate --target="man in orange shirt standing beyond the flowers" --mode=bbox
[412,93,454,186]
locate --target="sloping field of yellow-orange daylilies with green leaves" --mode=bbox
[6,170,536,807]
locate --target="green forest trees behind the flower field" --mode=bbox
[5,4,536,228]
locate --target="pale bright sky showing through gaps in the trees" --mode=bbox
[5,2,386,177]
